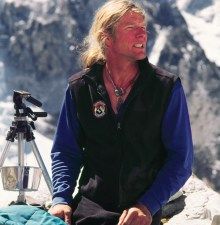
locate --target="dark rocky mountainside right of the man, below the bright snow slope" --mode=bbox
[146,1,220,190]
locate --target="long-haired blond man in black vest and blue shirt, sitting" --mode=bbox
[50,0,192,225]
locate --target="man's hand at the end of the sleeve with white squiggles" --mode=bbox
[48,204,72,225]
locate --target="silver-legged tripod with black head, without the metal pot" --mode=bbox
[0,91,52,203]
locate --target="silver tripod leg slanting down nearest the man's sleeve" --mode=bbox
[30,140,53,195]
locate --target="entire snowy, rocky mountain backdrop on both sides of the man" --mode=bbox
[0,0,220,213]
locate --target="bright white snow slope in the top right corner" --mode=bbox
[177,0,220,66]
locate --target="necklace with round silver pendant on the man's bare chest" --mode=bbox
[106,64,138,112]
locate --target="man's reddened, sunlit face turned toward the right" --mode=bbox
[107,11,147,61]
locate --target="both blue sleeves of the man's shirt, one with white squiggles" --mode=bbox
[51,78,193,215]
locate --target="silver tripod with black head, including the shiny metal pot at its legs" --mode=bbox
[0,91,52,203]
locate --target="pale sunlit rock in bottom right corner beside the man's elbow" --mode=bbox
[164,175,220,225]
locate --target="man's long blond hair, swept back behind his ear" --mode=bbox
[81,0,146,68]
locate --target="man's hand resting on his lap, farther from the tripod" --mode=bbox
[118,204,152,225]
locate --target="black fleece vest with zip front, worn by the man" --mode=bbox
[70,60,177,211]
